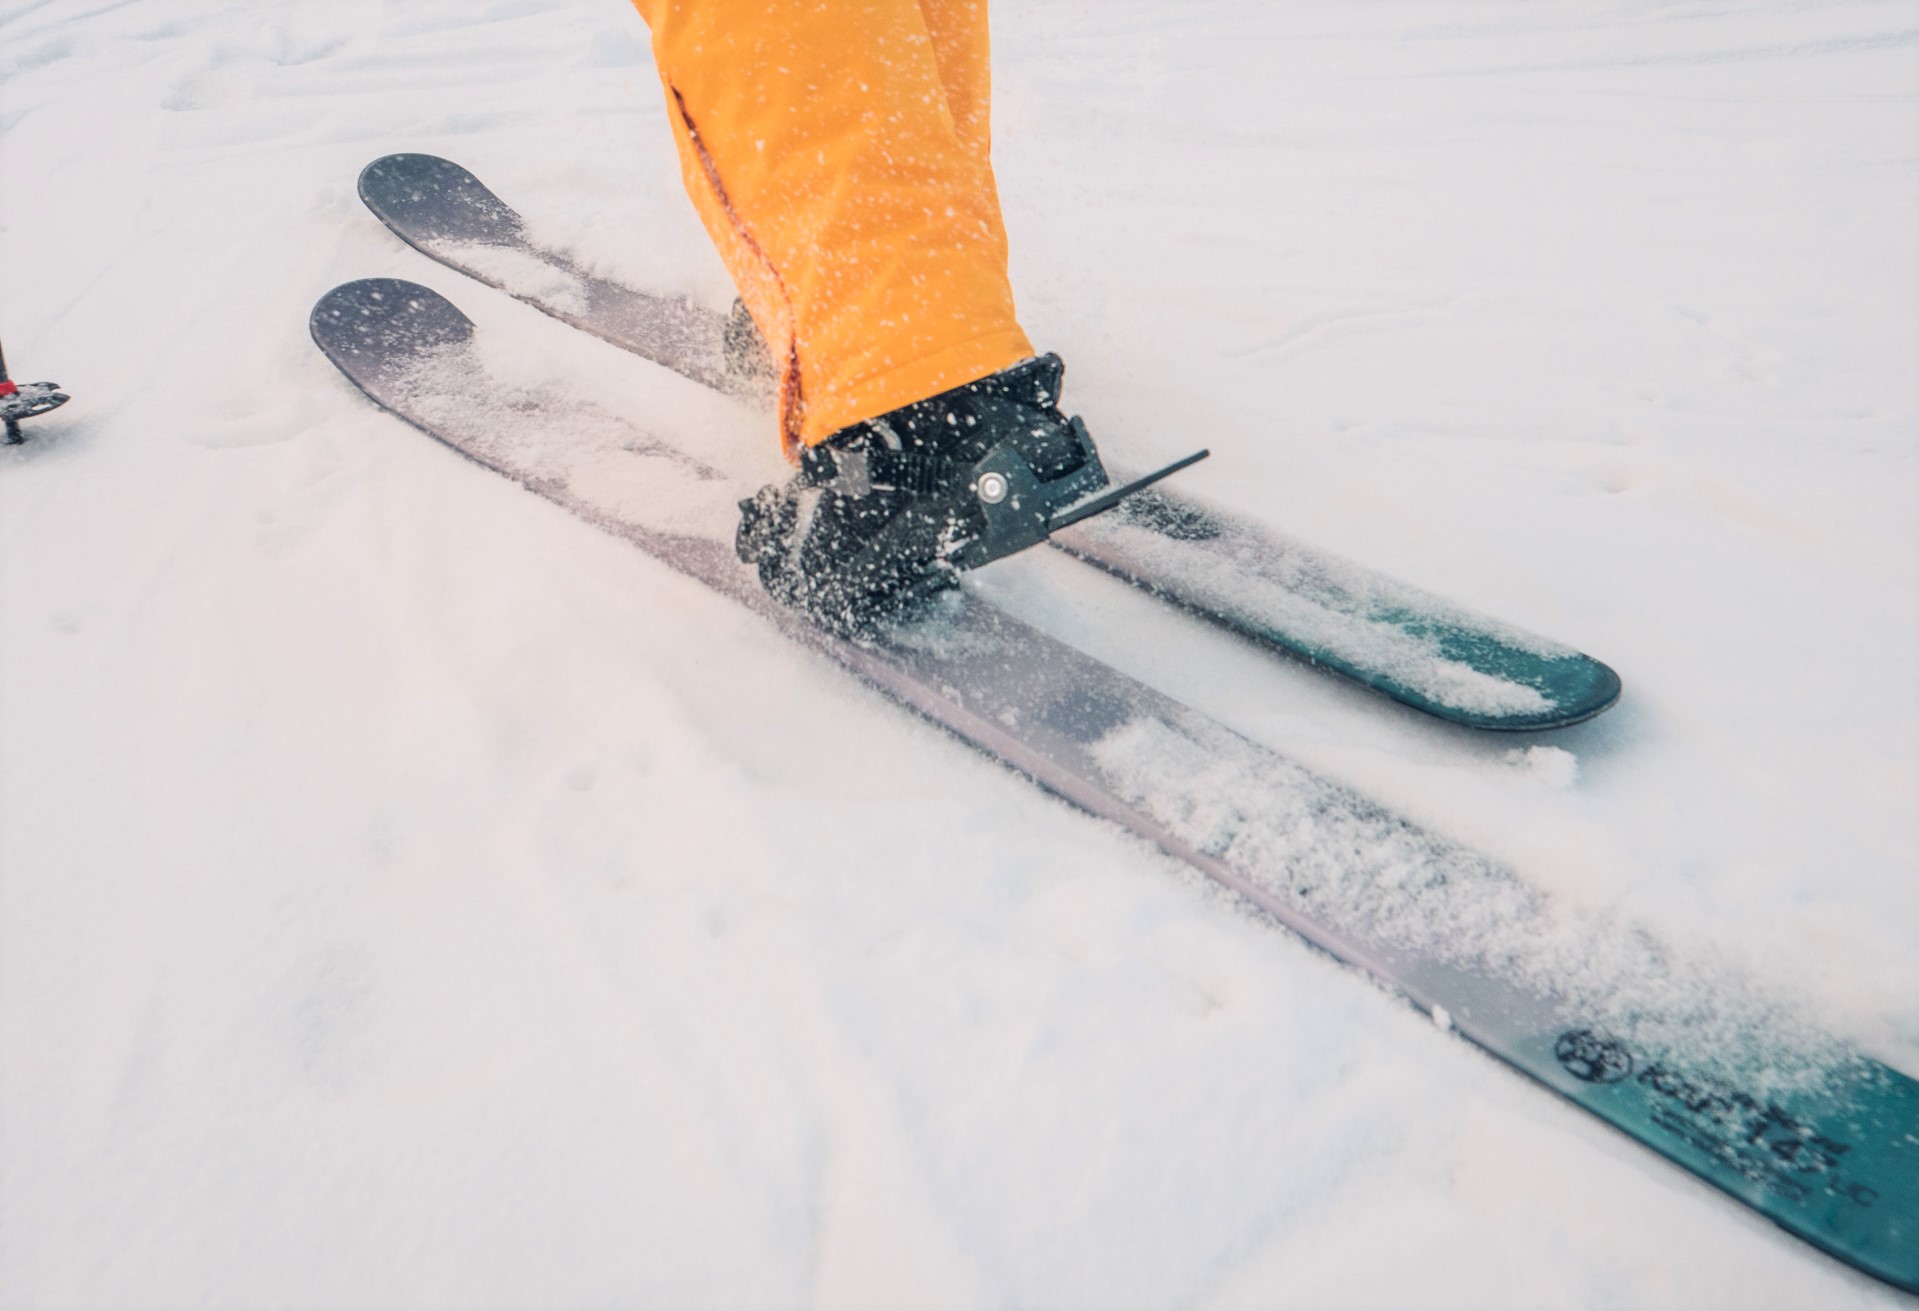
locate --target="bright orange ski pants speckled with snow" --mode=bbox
[633,0,1032,455]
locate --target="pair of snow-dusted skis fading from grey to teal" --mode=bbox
[311,155,1919,1290]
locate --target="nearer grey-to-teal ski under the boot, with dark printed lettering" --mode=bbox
[311,278,1919,1290]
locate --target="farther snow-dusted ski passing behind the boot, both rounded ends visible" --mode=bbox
[359,154,1620,731]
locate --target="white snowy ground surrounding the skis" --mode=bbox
[0,0,1919,1309]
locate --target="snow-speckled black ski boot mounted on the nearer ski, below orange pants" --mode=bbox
[735,355,1107,632]
